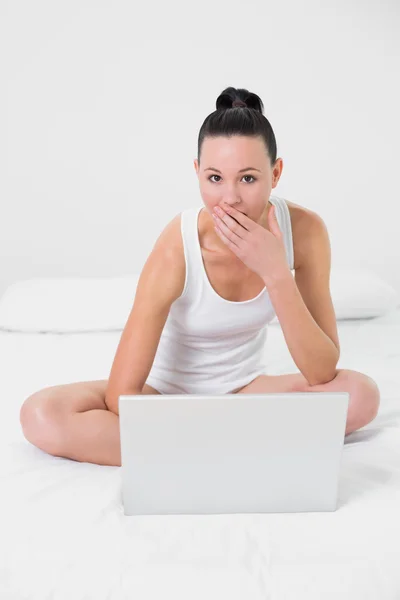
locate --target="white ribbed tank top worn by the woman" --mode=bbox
[147,196,294,394]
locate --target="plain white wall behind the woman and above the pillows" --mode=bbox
[0,0,400,294]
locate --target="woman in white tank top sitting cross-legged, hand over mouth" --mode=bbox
[20,87,379,466]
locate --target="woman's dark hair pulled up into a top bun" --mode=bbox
[197,87,277,166]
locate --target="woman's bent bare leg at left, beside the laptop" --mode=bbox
[20,380,158,466]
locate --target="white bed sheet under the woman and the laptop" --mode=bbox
[0,309,400,600]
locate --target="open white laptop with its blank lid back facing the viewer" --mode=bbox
[119,392,350,515]
